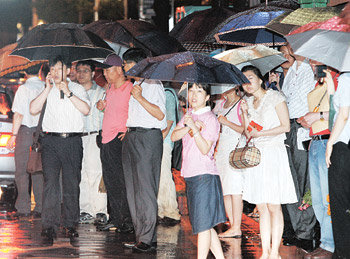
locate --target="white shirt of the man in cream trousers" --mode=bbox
[84,81,105,132]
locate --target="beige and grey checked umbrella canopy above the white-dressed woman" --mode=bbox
[214,45,287,75]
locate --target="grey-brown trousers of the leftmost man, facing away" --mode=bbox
[15,125,43,213]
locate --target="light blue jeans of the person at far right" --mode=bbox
[309,140,334,253]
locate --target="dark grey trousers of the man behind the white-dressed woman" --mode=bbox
[285,120,316,240]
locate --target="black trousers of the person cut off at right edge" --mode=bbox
[328,142,350,258]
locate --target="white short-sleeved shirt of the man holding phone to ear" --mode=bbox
[43,79,90,133]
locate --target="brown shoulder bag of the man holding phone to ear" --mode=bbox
[27,102,46,174]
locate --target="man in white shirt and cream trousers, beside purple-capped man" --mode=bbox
[76,60,107,224]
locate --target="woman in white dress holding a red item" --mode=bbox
[241,66,297,259]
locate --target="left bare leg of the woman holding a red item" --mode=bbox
[256,203,271,259]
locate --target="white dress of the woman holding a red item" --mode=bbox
[243,90,297,204]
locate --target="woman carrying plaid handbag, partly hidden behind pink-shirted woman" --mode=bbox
[213,88,244,238]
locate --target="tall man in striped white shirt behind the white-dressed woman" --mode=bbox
[282,45,316,252]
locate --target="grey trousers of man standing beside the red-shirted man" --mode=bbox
[122,128,163,247]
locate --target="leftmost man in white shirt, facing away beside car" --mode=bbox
[7,64,45,218]
